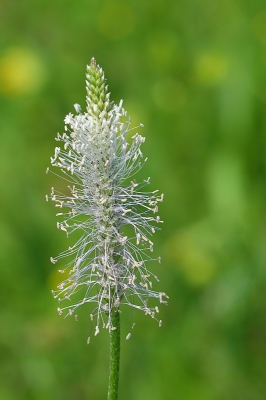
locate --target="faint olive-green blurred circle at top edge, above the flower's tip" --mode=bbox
[98,2,135,40]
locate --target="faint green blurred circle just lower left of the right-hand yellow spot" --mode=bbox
[152,78,187,113]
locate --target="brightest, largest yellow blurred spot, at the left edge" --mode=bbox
[0,48,44,95]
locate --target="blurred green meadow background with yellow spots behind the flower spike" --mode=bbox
[0,0,266,400]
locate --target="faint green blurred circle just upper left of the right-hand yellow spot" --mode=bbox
[148,31,178,68]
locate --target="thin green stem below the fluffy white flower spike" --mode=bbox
[108,309,120,400]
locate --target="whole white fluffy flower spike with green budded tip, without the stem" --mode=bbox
[46,58,167,335]
